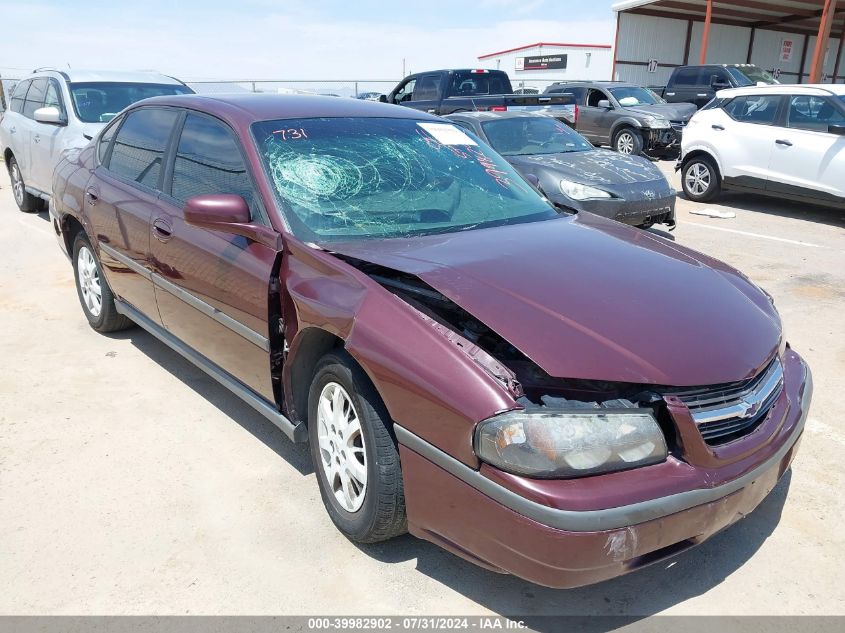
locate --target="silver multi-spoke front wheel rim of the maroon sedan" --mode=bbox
[317,382,367,512]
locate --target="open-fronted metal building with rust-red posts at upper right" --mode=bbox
[613,0,845,85]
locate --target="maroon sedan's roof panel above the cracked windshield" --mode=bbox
[132,93,441,125]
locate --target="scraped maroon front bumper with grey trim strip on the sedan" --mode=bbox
[396,355,812,588]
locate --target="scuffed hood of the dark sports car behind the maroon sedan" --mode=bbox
[505,149,668,188]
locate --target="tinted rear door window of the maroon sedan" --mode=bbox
[108,108,178,189]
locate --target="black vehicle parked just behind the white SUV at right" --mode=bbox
[649,64,779,108]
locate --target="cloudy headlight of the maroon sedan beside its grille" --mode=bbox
[475,408,668,479]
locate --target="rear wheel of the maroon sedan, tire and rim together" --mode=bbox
[73,232,133,333]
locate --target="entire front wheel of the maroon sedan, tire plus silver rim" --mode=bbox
[308,350,407,543]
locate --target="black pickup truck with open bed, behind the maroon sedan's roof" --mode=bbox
[379,69,575,119]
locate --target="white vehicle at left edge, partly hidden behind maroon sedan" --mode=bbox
[0,70,193,211]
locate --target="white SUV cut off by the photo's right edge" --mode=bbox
[678,84,845,208]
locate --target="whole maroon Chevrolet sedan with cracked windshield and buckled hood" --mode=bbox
[51,95,812,587]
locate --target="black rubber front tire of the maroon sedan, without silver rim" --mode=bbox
[308,350,408,543]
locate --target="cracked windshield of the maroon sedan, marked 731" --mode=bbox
[253,118,558,242]
